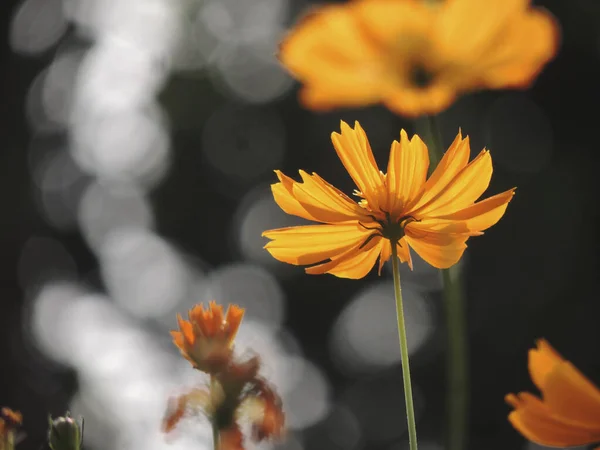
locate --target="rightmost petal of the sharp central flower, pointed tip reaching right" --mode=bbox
[436,188,515,231]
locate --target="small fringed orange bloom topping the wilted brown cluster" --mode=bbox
[171,301,244,373]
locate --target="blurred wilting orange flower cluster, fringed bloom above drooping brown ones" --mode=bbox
[164,302,285,450]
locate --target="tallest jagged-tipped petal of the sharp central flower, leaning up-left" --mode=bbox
[331,121,387,213]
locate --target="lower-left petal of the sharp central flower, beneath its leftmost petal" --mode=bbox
[306,236,384,280]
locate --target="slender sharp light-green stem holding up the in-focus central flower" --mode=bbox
[391,242,417,450]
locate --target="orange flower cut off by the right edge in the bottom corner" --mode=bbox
[506,339,600,449]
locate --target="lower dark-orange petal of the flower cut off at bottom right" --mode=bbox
[506,392,600,447]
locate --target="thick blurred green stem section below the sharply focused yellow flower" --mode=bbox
[442,266,469,450]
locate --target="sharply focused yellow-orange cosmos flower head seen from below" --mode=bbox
[263,122,514,278]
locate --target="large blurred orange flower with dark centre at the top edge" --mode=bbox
[279,0,559,116]
